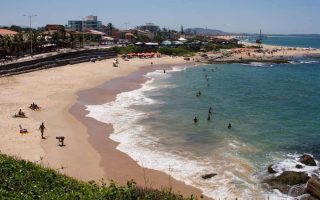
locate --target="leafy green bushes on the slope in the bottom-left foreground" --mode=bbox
[0,154,195,200]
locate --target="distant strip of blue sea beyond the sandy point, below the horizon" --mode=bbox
[243,35,320,49]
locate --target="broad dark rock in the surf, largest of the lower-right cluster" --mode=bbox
[264,171,310,194]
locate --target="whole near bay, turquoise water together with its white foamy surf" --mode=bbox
[87,60,320,199]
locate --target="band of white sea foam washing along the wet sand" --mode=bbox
[86,67,288,199]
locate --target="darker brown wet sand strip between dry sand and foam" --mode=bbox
[70,63,210,197]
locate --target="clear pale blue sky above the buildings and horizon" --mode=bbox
[0,0,320,34]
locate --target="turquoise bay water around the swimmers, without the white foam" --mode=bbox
[141,62,320,166]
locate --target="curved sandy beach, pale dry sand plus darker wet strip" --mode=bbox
[0,57,209,196]
